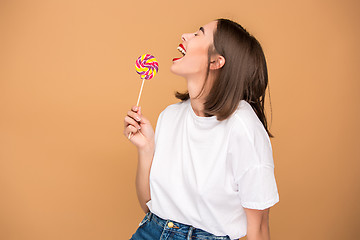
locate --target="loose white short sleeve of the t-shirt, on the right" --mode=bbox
[229,114,279,210]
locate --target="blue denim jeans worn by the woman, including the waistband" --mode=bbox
[130,212,230,240]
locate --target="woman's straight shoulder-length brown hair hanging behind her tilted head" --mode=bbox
[175,19,274,138]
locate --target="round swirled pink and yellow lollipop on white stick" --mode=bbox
[128,54,159,139]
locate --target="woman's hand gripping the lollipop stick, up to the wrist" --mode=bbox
[124,106,155,152]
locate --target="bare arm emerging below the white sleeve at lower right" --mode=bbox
[244,208,270,240]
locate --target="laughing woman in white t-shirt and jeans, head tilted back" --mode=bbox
[124,19,279,240]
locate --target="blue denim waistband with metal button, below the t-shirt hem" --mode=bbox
[146,212,230,240]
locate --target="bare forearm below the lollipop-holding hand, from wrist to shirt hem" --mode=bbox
[136,149,154,213]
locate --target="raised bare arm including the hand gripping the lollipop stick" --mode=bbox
[124,106,155,213]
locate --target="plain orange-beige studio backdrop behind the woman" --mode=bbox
[0,0,360,240]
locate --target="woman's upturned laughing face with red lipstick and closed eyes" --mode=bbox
[170,21,217,79]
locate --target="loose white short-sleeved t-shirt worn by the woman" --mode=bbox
[147,100,279,239]
